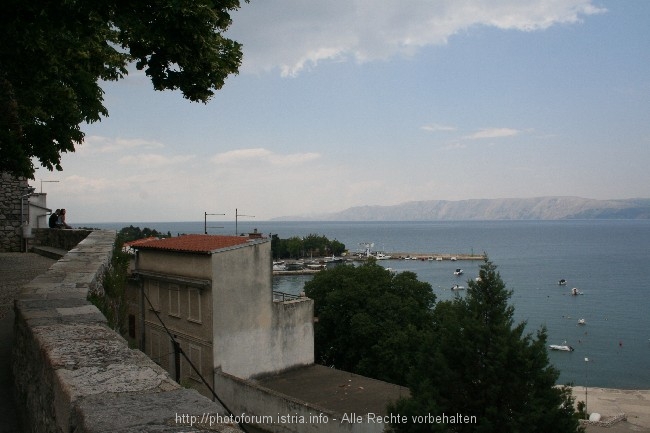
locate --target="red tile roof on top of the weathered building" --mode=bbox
[131,235,249,253]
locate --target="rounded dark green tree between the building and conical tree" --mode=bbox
[305,260,435,384]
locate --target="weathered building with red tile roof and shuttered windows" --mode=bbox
[129,235,314,396]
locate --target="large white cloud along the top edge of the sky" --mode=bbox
[228,0,606,76]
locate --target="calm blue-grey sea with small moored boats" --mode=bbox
[84,220,650,389]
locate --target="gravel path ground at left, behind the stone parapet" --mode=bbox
[0,253,56,319]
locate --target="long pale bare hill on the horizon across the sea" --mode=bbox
[275,197,650,221]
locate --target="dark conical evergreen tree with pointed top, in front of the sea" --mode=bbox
[389,257,578,433]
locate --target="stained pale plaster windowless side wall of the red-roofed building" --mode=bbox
[212,239,314,378]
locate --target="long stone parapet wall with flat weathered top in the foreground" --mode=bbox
[12,231,239,433]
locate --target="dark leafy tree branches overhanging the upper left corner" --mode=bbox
[0,0,242,178]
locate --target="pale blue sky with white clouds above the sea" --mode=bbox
[32,0,650,225]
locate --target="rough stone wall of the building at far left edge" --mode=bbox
[0,173,29,252]
